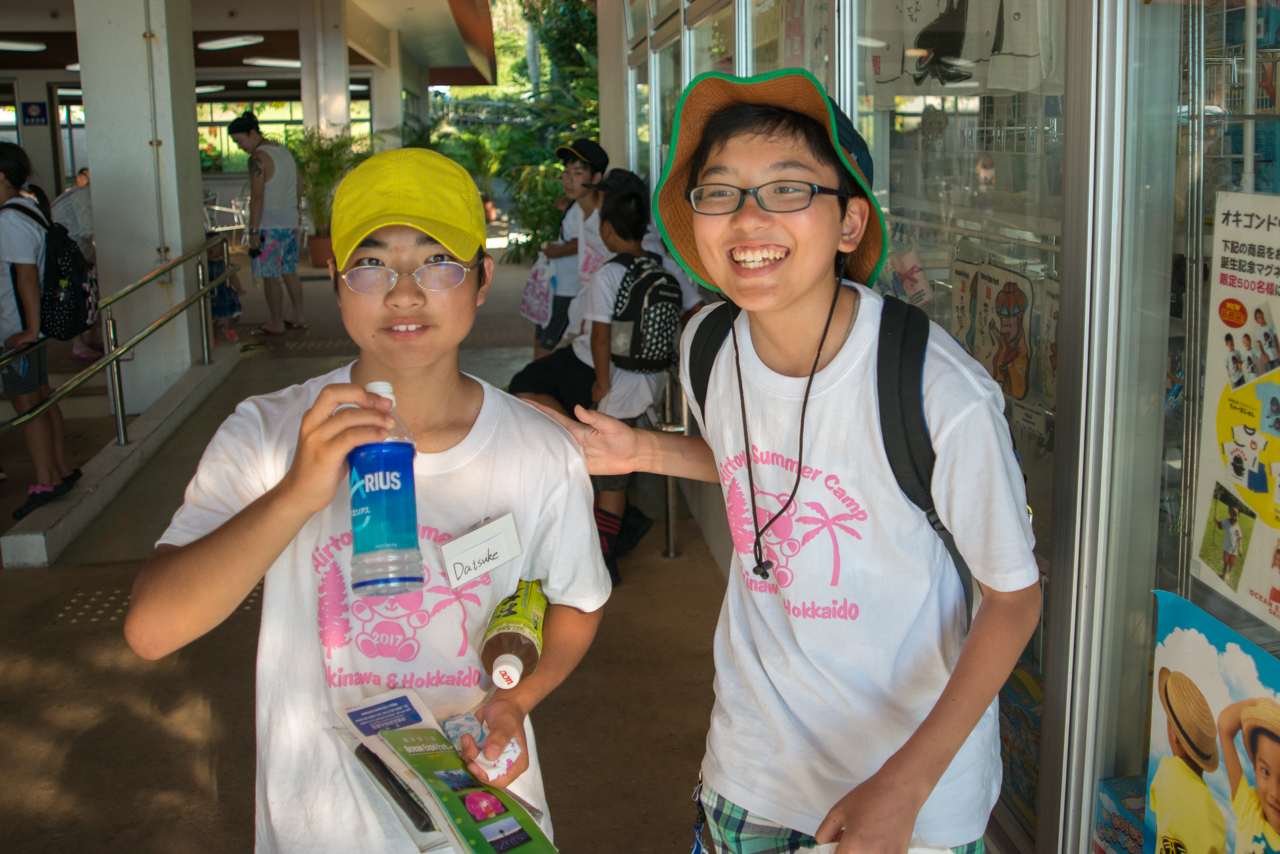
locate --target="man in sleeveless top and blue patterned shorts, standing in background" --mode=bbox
[227,113,307,337]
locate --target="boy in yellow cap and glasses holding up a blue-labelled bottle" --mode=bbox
[125,149,609,854]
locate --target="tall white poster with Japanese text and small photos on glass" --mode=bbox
[1192,192,1280,627]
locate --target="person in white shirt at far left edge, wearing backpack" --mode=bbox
[0,142,81,519]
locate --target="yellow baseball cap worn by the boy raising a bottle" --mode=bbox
[330,149,485,270]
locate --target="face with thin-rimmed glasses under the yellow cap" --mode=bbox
[330,225,493,370]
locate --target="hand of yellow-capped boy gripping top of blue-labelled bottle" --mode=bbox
[280,383,393,513]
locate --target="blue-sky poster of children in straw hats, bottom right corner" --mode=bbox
[1142,593,1280,854]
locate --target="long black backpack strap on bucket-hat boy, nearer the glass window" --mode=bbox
[876,297,973,625]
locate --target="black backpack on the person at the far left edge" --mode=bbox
[0,204,97,341]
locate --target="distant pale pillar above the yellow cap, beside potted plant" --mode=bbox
[298,0,351,134]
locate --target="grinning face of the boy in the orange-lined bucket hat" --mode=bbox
[694,134,870,312]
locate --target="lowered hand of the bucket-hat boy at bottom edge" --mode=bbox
[817,769,924,854]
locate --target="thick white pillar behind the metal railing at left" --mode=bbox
[76,0,205,414]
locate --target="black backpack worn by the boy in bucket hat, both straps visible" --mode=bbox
[689,297,1018,624]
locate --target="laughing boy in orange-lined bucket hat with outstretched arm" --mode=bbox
[535,69,1041,854]
